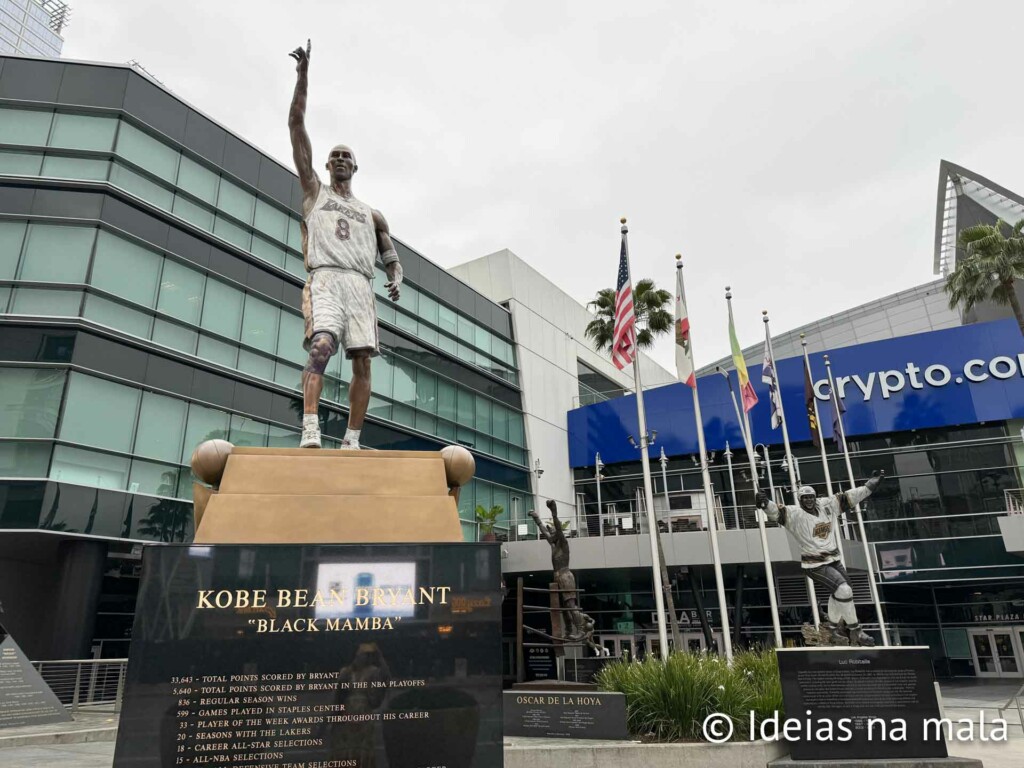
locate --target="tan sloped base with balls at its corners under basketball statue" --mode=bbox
[193,441,472,544]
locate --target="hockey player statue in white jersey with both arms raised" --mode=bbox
[757,472,886,646]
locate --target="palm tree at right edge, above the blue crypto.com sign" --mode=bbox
[946,219,1024,336]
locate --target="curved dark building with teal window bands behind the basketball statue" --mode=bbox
[0,57,529,657]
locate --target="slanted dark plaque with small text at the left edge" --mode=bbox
[0,625,71,728]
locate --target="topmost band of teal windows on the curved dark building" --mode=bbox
[0,108,517,384]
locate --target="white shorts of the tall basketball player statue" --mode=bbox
[302,267,380,357]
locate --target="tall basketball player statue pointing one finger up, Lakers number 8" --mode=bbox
[288,40,402,450]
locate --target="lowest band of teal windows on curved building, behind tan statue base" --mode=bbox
[0,366,522,541]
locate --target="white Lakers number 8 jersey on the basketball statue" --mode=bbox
[303,183,377,280]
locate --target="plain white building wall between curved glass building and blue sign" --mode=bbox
[449,249,675,528]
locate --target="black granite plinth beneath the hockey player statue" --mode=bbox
[767,646,946,760]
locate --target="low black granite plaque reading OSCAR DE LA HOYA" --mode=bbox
[504,690,629,739]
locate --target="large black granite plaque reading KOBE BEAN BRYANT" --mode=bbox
[114,544,502,768]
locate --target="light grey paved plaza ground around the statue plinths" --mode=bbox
[0,680,1024,768]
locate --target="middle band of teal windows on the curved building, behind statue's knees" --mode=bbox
[0,220,526,465]
